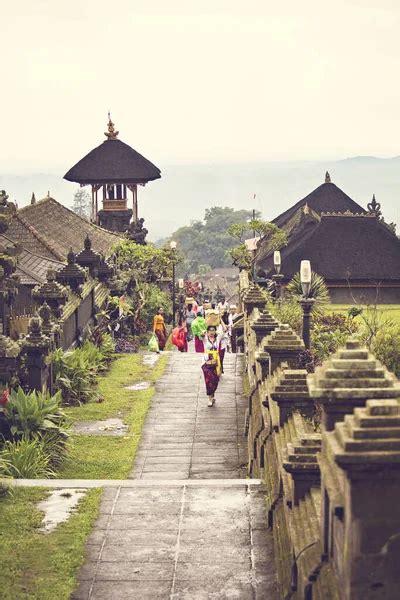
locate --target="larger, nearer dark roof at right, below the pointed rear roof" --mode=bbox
[257,210,400,281]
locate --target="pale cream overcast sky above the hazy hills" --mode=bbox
[0,0,400,173]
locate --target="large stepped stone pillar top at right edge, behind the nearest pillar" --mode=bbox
[307,339,400,431]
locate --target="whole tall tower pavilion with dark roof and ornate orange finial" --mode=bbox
[64,113,161,232]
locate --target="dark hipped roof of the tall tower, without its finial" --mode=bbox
[64,139,161,183]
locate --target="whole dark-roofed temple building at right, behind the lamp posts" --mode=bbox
[255,173,400,304]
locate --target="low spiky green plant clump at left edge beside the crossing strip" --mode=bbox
[0,438,55,479]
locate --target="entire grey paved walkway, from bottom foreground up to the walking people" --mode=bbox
[73,353,276,600]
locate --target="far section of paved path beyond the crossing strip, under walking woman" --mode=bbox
[131,352,247,479]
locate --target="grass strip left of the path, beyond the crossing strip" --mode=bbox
[59,354,167,479]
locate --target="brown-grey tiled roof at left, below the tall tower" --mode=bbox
[17,197,121,260]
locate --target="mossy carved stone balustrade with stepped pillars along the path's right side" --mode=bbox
[240,274,400,600]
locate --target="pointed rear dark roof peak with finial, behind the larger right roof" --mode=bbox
[272,183,366,227]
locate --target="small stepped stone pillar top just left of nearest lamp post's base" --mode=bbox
[262,325,304,373]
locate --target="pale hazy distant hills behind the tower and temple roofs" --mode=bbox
[0,156,400,240]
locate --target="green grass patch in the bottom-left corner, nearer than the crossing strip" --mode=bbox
[0,488,102,600]
